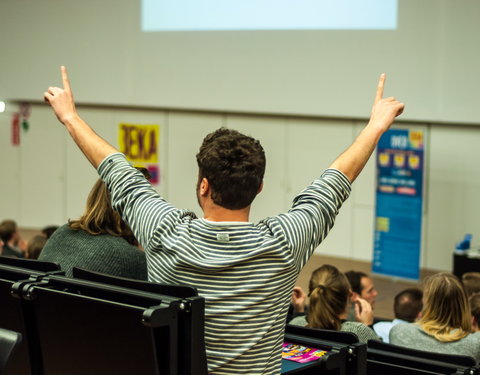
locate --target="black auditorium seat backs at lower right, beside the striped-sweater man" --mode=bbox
[282,325,480,375]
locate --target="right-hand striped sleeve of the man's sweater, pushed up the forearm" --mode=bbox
[278,169,351,268]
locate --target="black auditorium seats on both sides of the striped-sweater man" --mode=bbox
[0,257,480,375]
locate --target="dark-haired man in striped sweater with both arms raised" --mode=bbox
[44,67,404,375]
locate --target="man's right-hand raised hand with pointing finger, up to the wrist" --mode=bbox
[370,74,405,132]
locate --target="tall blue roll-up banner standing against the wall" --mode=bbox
[372,129,425,280]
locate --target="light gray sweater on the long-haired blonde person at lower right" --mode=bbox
[390,323,480,363]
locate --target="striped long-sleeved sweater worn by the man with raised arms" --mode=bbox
[98,153,350,375]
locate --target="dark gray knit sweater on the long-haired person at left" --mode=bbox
[38,224,147,280]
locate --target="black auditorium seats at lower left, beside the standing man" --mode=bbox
[0,257,207,375]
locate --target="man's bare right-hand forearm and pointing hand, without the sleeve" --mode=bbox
[330,74,405,182]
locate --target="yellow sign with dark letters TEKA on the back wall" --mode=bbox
[118,124,160,163]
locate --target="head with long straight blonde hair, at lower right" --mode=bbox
[418,272,471,342]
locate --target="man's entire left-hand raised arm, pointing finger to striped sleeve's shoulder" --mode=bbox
[44,66,183,250]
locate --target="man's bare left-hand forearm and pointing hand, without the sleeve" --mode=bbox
[44,66,118,168]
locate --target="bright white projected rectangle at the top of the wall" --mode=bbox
[142,0,398,31]
